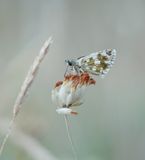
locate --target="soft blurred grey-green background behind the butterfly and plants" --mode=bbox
[0,0,145,160]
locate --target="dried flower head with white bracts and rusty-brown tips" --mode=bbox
[52,72,95,115]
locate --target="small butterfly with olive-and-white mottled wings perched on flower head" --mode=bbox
[65,49,116,77]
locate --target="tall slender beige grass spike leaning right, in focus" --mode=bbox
[0,37,52,156]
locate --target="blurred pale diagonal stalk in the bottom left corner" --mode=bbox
[0,118,58,160]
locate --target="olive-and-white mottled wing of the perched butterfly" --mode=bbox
[77,49,116,77]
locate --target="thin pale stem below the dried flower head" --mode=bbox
[64,115,78,160]
